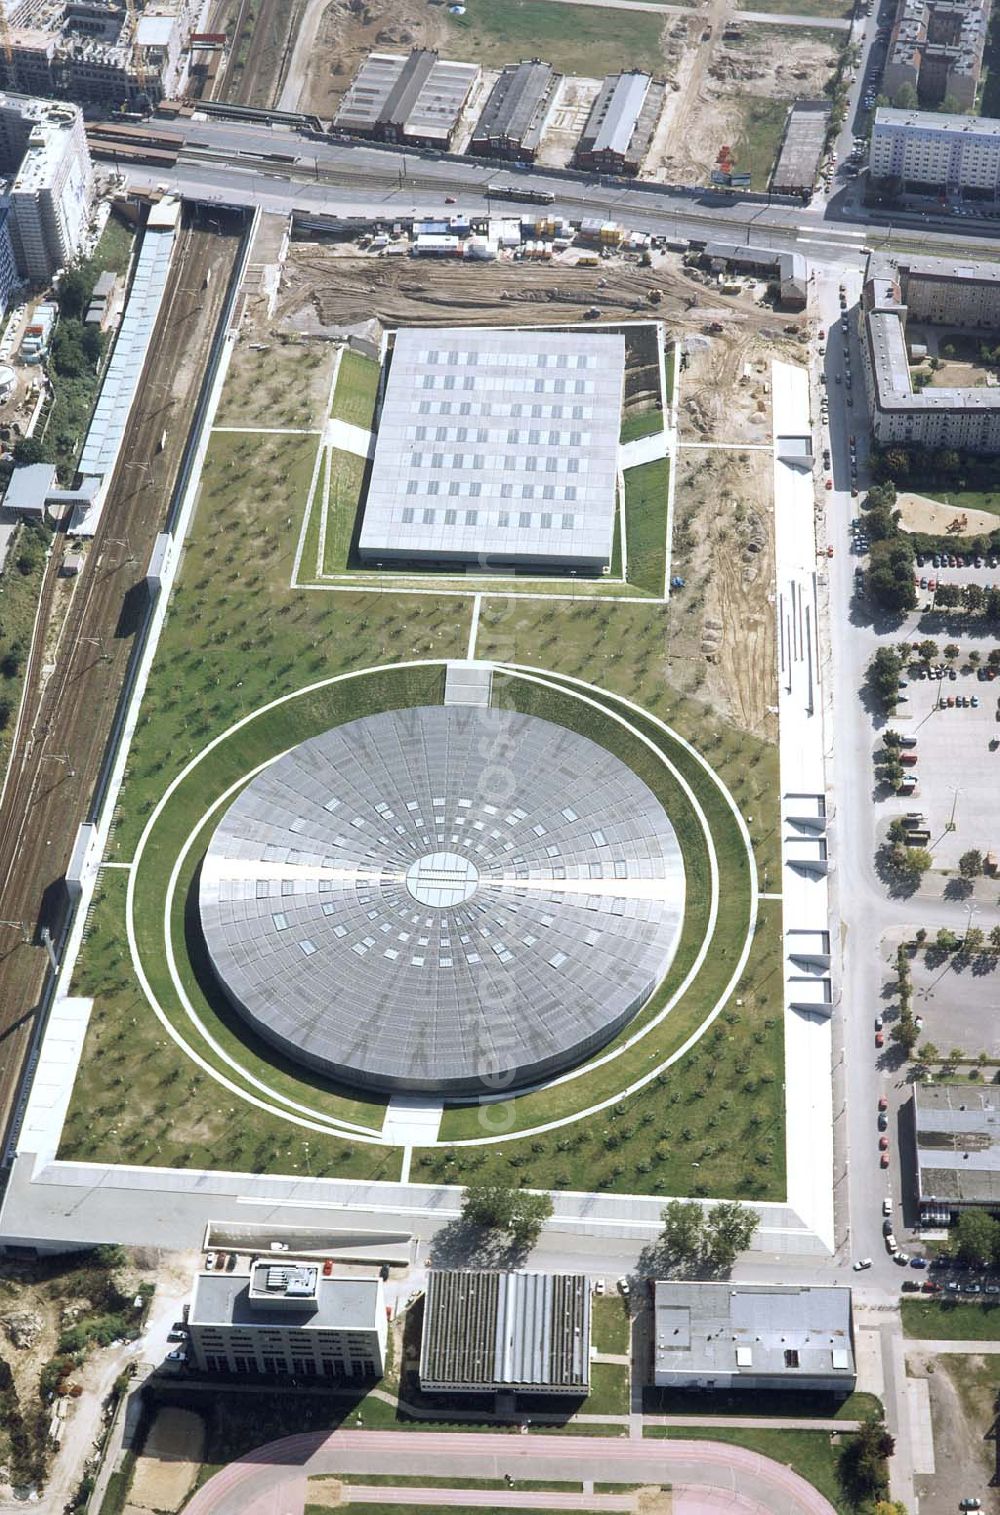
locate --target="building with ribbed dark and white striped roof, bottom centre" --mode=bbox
[420,1268,591,1397]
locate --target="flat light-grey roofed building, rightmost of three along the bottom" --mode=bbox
[653,1280,856,1395]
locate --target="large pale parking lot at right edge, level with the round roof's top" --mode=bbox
[885,667,1000,870]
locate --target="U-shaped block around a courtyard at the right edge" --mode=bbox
[861,253,1000,453]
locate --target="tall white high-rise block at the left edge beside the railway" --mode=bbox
[0,94,94,283]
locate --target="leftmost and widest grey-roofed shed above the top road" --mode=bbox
[333,48,479,150]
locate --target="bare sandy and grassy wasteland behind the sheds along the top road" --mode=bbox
[278,0,847,189]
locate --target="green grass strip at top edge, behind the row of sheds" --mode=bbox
[442,0,664,79]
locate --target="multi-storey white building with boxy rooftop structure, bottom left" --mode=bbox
[188,1259,388,1382]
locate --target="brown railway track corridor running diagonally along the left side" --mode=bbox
[0,212,241,1151]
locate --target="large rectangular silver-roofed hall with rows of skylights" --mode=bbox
[359,327,624,573]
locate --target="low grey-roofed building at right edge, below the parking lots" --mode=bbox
[914,1083,1000,1215]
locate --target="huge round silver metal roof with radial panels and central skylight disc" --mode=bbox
[200,706,685,1098]
